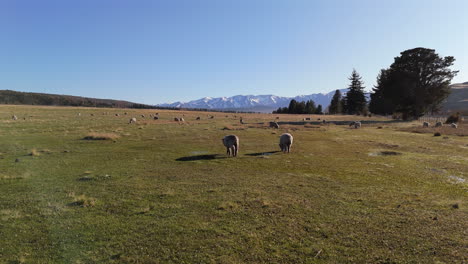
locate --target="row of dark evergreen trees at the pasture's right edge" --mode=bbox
[275,48,458,120]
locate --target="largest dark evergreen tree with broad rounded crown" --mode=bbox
[375,48,458,119]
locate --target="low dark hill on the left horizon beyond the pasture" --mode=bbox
[0,90,159,108]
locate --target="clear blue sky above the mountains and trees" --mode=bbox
[0,0,468,104]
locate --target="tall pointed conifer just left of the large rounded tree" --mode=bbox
[346,70,367,115]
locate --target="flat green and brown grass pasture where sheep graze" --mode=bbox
[0,106,468,263]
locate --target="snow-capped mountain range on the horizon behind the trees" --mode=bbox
[159,89,347,112]
